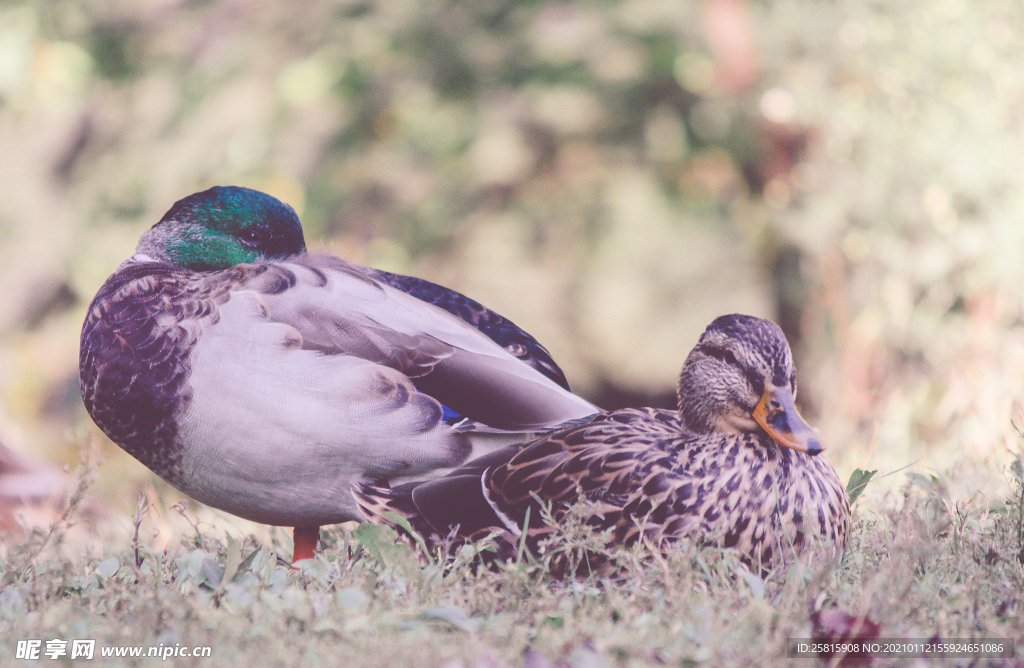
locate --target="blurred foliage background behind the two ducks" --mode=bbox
[0,0,1024,524]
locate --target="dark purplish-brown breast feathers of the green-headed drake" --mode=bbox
[80,262,266,485]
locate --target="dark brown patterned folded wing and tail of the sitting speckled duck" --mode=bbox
[354,409,681,536]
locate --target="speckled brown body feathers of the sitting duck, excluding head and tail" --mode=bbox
[484,409,850,563]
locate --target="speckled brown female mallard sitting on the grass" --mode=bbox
[356,315,850,566]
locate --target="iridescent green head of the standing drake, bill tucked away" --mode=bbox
[135,185,306,272]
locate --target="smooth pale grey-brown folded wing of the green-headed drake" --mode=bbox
[250,255,599,431]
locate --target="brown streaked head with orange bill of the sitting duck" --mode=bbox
[678,315,823,455]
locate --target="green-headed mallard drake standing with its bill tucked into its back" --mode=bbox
[80,187,598,559]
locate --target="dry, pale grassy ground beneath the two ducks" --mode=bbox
[0,450,1024,668]
